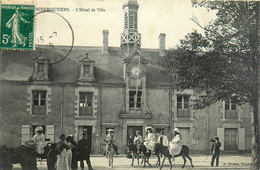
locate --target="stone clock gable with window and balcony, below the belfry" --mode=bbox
[121,49,151,118]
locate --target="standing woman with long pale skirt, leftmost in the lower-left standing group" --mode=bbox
[57,134,69,170]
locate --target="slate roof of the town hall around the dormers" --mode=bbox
[0,46,170,85]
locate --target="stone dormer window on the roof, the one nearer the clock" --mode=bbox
[78,53,94,82]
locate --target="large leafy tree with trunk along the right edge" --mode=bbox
[164,1,260,170]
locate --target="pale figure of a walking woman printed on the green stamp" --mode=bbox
[6,8,30,47]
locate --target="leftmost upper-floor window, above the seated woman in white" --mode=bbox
[32,90,47,115]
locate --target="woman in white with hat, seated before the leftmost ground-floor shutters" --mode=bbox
[32,126,45,155]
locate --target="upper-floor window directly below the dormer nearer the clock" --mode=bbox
[79,92,93,115]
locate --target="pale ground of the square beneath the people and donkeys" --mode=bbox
[13,154,251,170]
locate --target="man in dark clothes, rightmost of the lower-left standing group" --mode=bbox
[78,130,94,170]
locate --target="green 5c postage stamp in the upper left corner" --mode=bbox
[0,4,35,50]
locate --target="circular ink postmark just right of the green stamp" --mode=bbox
[25,11,74,64]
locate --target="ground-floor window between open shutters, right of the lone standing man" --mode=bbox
[224,128,237,150]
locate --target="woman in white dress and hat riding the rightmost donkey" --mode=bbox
[170,128,182,158]
